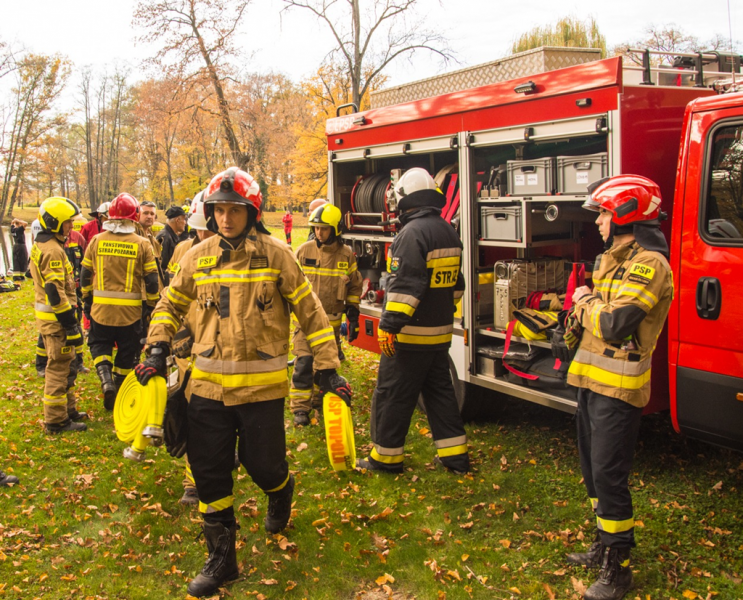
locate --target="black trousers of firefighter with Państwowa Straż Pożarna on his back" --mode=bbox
[88,319,142,383]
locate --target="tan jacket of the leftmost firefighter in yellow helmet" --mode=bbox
[30,231,77,335]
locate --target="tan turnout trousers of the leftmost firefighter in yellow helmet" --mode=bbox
[41,330,77,425]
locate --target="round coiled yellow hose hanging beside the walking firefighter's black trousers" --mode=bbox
[114,371,168,461]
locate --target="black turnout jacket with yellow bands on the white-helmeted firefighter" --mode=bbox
[379,208,464,350]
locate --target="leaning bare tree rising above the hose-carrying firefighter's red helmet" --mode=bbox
[134,0,250,168]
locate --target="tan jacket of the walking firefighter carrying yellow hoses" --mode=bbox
[147,229,340,406]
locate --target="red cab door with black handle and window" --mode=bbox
[671,106,743,450]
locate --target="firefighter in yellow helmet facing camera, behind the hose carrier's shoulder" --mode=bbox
[289,204,361,427]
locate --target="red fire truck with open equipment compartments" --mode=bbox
[326,49,743,449]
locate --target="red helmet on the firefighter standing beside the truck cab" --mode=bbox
[583,175,661,225]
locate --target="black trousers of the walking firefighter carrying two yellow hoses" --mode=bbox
[186,394,289,524]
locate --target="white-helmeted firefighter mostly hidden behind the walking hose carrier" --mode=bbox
[168,192,215,506]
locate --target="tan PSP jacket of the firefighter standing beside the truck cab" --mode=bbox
[568,241,673,407]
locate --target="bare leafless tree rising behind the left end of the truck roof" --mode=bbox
[283,0,453,106]
